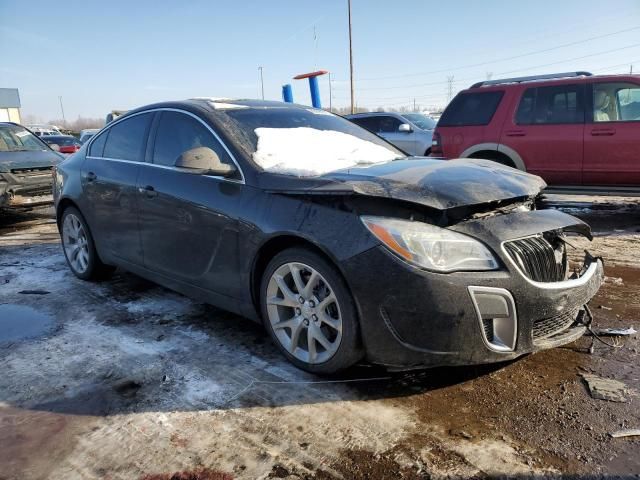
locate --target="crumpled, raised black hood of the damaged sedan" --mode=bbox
[263,157,546,210]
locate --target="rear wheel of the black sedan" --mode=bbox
[60,207,115,280]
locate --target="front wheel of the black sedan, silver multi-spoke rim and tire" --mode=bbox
[260,248,362,374]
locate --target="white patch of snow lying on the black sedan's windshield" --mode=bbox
[253,127,401,177]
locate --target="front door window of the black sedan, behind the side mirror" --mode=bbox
[153,112,233,166]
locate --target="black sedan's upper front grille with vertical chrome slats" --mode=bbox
[504,232,567,282]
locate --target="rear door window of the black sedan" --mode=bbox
[103,113,152,161]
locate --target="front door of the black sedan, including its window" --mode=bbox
[137,110,244,297]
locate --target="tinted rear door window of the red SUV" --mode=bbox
[516,85,584,125]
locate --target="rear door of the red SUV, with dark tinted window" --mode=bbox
[500,84,584,185]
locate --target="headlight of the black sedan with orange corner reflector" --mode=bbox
[360,216,498,272]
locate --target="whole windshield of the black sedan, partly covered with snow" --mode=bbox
[226,107,405,177]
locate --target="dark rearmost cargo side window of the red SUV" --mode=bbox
[438,91,504,127]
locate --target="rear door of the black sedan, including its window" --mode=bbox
[81,112,154,265]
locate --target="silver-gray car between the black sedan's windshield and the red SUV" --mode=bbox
[345,112,436,156]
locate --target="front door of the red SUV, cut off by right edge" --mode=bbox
[583,81,640,186]
